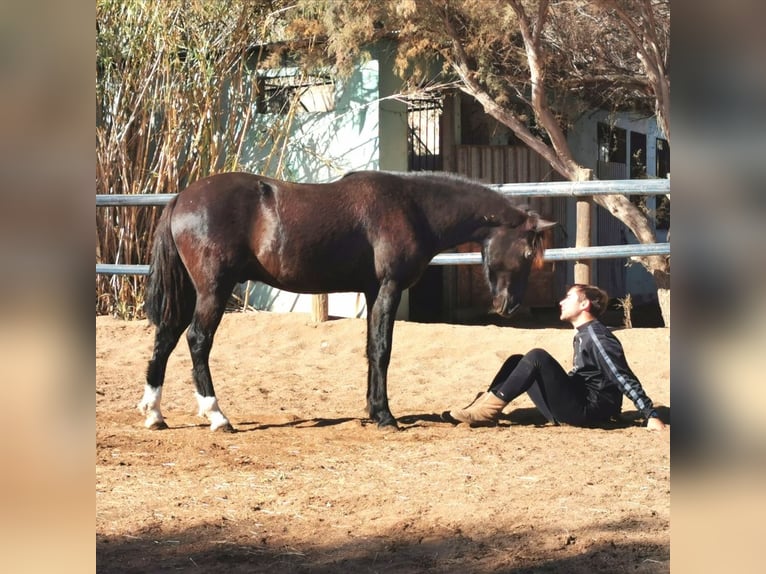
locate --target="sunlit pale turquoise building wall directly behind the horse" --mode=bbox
[241,59,409,318]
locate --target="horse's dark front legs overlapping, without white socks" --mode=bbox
[366,281,402,428]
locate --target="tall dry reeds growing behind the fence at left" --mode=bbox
[96,0,300,317]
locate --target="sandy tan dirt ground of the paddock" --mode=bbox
[96,313,670,573]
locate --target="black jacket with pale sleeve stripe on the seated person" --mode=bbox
[570,320,657,419]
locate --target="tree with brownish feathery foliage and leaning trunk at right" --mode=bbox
[287,0,670,324]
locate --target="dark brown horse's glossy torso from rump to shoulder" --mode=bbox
[172,173,427,293]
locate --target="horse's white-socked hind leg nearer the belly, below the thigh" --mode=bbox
[186,290,234,432]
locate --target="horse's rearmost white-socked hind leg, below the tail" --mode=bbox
[138,317,190,430]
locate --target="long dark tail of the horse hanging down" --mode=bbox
[144,197,196,326]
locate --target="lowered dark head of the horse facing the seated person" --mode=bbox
[482,212,556,317]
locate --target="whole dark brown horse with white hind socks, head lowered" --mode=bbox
[138,171,554,431]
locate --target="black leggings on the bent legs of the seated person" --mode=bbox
[489,349,589,426]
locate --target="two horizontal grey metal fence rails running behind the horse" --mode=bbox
[96,179,670,275]
